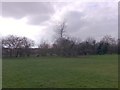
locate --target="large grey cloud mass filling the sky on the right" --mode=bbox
[63,2,118,39]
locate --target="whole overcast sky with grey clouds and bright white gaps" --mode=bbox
[0,0,118,43]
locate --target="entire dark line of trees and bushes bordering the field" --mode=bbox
[1,22,120,57]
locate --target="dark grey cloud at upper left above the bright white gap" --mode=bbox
[2,2,54,24]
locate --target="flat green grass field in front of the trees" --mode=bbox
[3,55,118,88]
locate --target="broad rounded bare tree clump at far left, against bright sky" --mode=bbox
[2,35,34,57]
